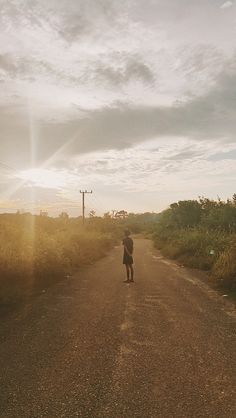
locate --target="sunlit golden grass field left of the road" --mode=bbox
[0,214,121,310]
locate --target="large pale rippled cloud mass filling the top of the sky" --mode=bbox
[0,0,233,118]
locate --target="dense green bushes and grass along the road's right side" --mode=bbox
[154,195,236,288]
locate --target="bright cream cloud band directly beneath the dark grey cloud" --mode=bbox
[11,138,235,199]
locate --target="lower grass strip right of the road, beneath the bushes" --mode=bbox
[153,229,236,289]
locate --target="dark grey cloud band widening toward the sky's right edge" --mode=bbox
[61,68,236,152]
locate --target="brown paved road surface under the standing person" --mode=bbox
[0,239,236,418]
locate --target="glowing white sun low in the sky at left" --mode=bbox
[17,168,66,189]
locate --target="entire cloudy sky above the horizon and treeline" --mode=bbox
[0,0,236,216]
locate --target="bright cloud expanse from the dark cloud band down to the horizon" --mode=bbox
[0,138,236,216]
